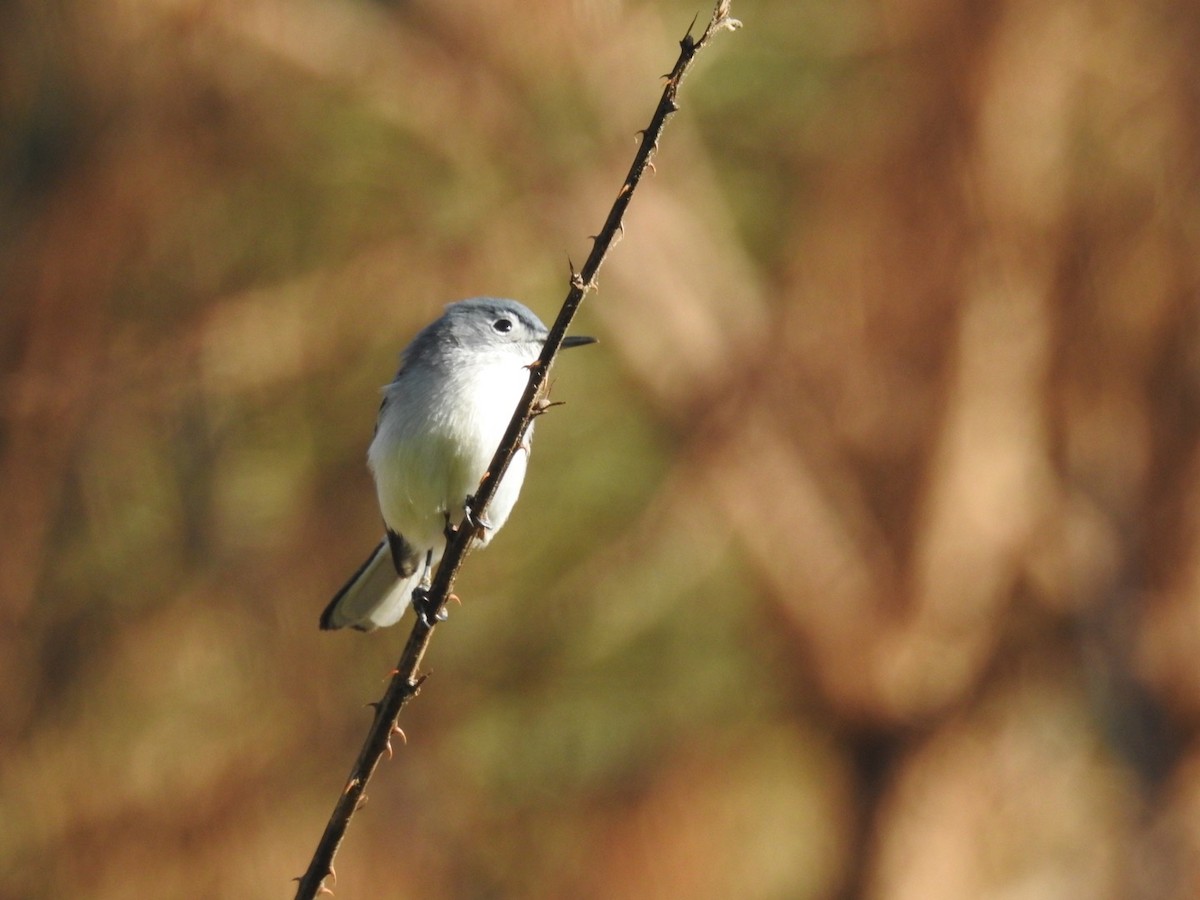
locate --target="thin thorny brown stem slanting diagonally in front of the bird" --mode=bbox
[296,0,742,900]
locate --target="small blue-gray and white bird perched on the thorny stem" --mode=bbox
[320,296,595,631]
